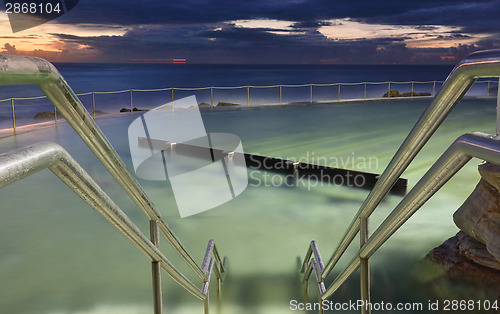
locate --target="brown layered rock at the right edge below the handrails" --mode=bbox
[453,163,500,262]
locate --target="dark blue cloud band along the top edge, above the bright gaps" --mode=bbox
[56,0,498,27]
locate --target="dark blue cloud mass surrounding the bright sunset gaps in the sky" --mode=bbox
[9,0,500,63]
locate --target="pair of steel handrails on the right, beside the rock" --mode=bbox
[300,50,500,314]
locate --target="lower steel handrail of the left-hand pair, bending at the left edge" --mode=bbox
[0,143,206,300]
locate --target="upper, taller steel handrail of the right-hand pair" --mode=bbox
[301,50,500,313]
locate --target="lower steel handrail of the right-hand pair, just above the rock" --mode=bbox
[301,132,500,313]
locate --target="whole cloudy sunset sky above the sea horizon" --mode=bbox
[0,0,500,64]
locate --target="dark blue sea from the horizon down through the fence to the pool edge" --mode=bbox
[0,63,453,128]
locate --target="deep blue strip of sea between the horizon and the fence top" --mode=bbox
[0,63,453,98]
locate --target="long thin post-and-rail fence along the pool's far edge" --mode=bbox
[0,79,498,133]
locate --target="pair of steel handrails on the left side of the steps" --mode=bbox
[0,54,225,314]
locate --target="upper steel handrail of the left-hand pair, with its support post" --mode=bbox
[0,54,224,313]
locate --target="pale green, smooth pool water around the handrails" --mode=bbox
[0,99,495,314]
